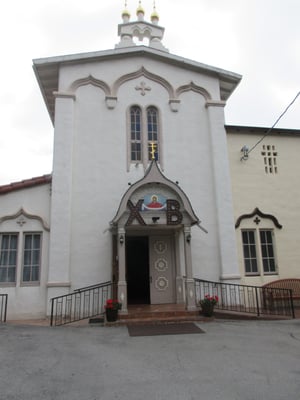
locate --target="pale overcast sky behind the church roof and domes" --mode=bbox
[0,0,300,184]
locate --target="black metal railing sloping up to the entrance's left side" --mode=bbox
[50,282,113,326]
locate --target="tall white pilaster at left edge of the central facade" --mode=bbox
[47,93,75,310]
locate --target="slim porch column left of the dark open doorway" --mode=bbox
[118,228,128,314]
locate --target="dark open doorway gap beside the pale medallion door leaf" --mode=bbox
[126,236,150,304]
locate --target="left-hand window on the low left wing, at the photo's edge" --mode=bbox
[0,233,18,283]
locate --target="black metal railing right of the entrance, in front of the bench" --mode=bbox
[195,278,295,318]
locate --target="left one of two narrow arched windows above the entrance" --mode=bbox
[130,106,142,162]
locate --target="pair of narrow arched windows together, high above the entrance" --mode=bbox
[127,105,161,170]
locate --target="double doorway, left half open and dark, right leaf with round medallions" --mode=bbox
[126,235,175,304]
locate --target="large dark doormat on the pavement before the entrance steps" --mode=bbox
[127,322,205,336]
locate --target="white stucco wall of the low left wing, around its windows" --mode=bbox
[0,184,50,320]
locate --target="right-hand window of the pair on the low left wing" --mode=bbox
[22,233,41,282]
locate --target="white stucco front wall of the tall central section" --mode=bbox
[49,53,236,293]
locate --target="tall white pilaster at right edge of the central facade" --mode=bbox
[206,102,240,280]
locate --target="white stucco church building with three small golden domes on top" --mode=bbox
[0,1,300,319]
